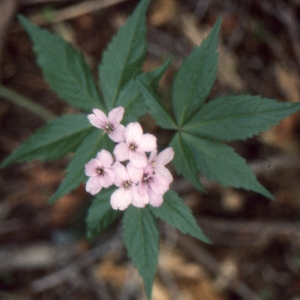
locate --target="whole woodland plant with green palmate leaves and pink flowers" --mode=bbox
[2,0,300,299]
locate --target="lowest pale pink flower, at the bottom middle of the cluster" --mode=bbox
[110,161,148,210]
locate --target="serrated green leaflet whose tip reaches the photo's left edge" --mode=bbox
[1,114,92,167]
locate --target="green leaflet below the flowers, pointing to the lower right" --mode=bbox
[149,190,210,243]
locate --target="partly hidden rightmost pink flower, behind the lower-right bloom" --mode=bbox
[149,147,174,183]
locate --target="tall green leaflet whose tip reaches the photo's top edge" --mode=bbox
[99,0,149,110]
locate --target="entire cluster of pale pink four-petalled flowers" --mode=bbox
[85,107,174,210]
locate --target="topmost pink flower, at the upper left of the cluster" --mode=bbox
[88,106,125,143]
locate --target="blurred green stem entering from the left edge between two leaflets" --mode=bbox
[0,85,56,121]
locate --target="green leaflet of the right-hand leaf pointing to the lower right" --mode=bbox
[182,134,273,199]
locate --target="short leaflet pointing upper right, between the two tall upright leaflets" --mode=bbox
[116,61,170,124]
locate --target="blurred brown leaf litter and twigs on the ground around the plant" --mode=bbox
[0,0,300,300]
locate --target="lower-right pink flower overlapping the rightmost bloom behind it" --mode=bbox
[138,164,170,207]
